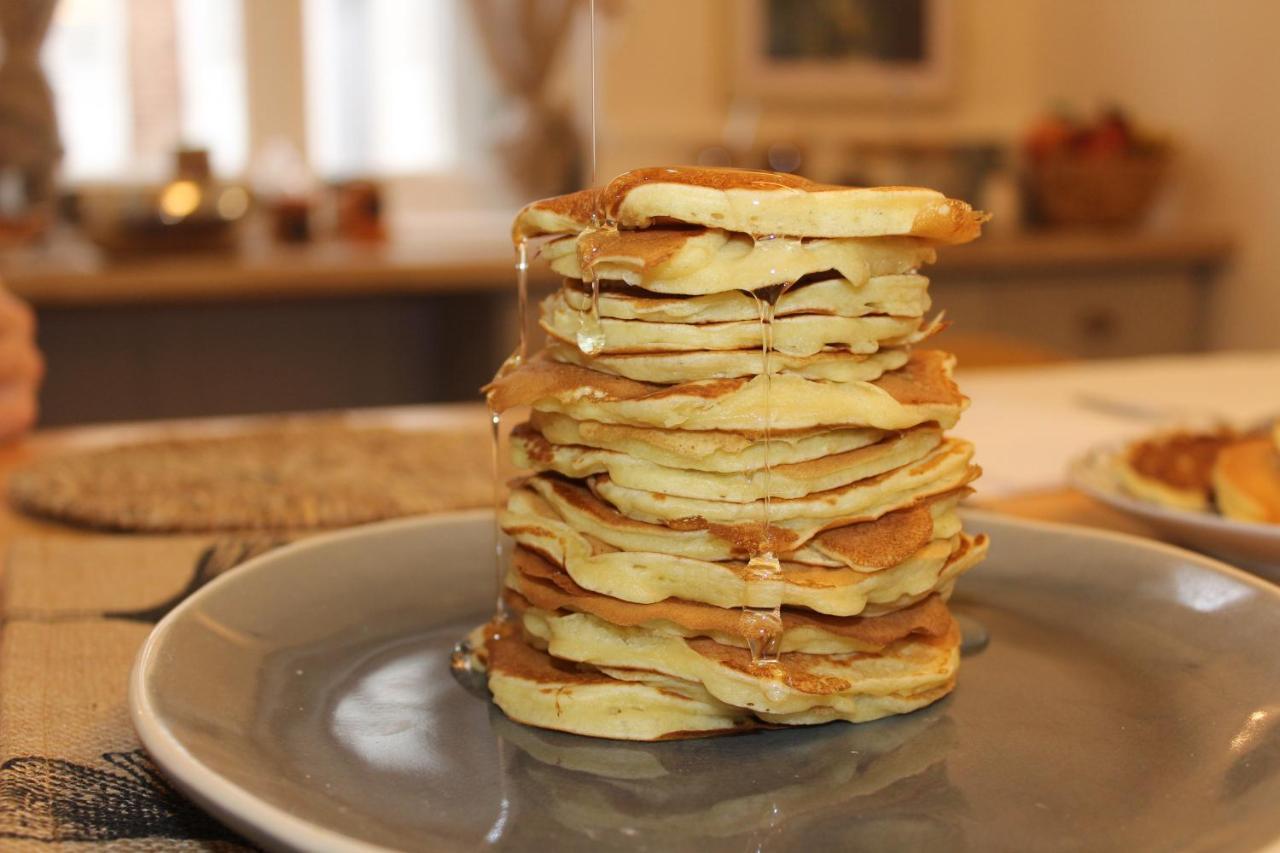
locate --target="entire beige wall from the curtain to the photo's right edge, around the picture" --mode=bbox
[586,0,1280,347]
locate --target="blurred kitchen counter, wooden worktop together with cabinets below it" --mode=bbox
[0,224,1231,425]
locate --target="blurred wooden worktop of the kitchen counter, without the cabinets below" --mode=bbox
[0,225,1233,307]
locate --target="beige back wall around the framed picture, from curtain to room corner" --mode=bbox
[599,0,1041,175]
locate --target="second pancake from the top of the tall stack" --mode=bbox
[541,228,937,296]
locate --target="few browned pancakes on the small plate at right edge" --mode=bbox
[1115,421,1280,524]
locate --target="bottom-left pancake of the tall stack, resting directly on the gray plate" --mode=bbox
[477,625,760,740]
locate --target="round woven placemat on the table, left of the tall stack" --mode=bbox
[9,424,493,533]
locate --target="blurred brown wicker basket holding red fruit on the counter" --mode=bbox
[1027,149,1169,225]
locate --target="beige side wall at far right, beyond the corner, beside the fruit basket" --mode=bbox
[1041,0,1280,348]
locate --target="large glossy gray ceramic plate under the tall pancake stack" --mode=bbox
[131,514,1280,852]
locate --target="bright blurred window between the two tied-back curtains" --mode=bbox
[44,0,473,182]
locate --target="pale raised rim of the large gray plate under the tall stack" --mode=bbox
[128,507,1280,853]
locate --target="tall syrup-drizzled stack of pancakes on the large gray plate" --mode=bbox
[484,169,987,739]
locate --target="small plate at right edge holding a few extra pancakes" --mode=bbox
[1070,446,1280,581]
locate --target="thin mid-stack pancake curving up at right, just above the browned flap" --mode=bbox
[588,438,973,525]
